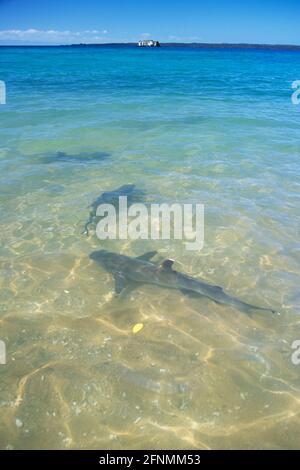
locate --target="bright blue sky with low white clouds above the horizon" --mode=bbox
[0,0,300,45]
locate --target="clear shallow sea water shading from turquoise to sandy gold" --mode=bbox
[0,47,300,449]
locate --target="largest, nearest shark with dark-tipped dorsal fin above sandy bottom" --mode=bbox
[90,250,276,314]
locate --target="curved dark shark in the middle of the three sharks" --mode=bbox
[82,184,144,235]
